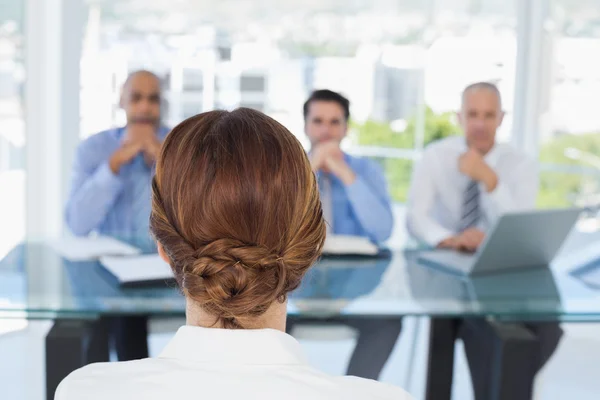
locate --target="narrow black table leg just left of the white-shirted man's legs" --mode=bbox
[425,318,459,400]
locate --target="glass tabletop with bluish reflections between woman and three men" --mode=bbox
[0,241,600,322]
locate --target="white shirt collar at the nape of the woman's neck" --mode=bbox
[159,326,308,365]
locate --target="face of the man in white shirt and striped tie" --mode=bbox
[458,89,504,155]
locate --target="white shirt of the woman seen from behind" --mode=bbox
[55,326,411,400]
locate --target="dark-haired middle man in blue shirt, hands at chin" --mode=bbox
[304,90,394,243]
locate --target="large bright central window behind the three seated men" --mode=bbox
[81,0,517,208]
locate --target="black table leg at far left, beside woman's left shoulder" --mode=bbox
[46,318,109,400]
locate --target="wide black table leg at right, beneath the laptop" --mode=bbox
[488,322,538,400]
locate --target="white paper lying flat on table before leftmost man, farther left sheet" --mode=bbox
[50,236,141,261]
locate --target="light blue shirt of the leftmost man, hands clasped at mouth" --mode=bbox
[65,127,169,247]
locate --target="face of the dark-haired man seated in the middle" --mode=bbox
[304,100,348,147]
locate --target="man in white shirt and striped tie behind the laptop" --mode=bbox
[407,82,562,400]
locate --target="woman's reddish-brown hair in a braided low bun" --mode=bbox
[150,108,325,329]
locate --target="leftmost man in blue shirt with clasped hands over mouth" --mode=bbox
[66,71,168,360]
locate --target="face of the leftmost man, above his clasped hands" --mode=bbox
[121,73,160,126]
